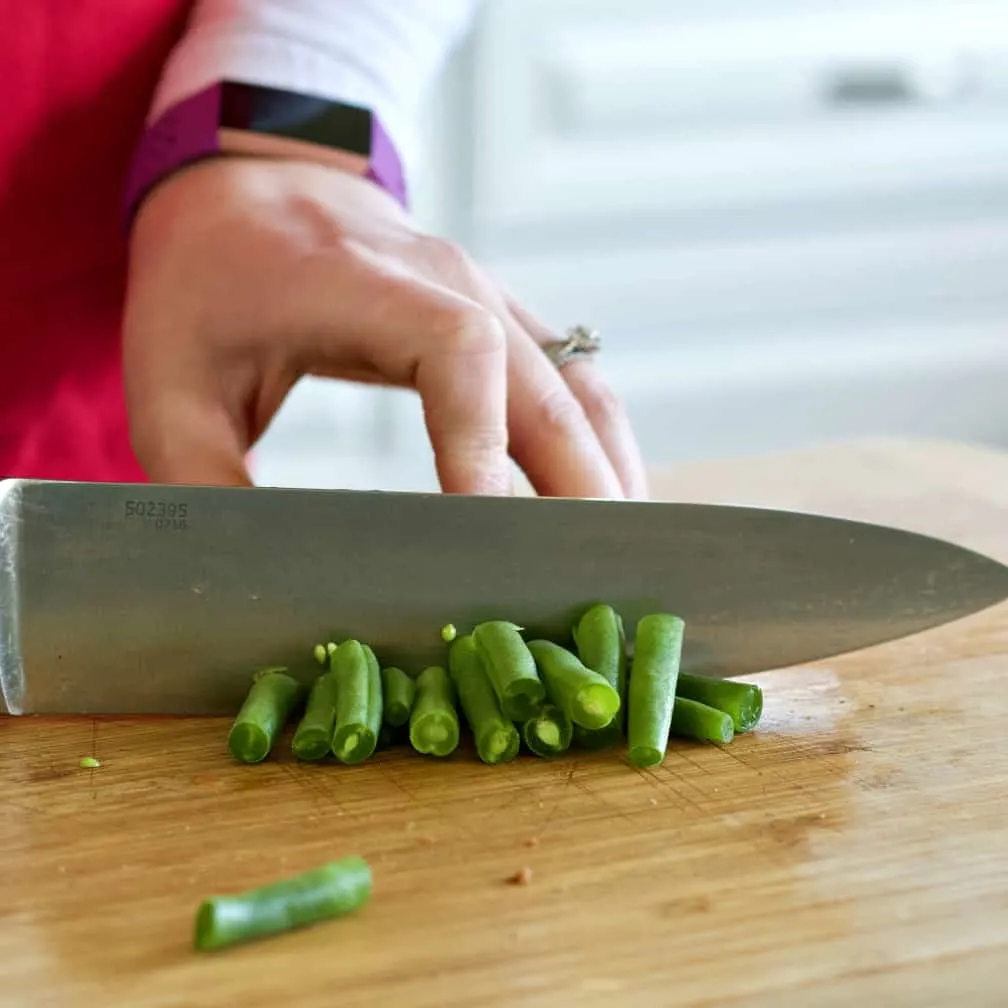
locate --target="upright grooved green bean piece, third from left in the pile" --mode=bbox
[330,640,382,763]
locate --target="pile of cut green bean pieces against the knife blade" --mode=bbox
[228,604,763,767]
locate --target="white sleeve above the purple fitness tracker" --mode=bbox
[148,0,480,179]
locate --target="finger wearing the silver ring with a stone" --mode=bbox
[508,298,648,500]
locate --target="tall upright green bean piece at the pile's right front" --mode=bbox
[627,613,684,766]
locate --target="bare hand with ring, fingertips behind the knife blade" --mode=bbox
[123,158,646,498]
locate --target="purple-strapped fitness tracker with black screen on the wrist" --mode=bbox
[125,82,408,223]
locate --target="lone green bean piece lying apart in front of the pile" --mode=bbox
[195,857,372,952]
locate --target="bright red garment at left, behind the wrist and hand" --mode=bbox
[0,0,192,482]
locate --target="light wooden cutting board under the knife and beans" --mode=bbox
[0,443,1008,1008]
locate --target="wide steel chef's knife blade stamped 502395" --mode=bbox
[0,480,1008,715]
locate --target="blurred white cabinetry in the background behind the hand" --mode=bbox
[247,0,1008,489]
